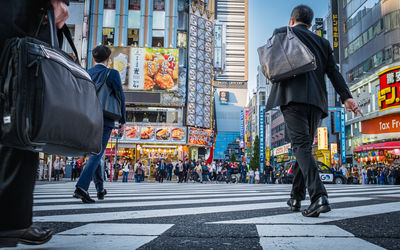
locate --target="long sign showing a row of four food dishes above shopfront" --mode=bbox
[122,125,186,144]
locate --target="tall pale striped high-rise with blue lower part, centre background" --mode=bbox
[214,0,248,160]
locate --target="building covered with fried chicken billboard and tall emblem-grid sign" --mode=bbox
[83,0,214,174]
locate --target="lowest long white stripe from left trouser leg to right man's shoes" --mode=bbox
[34,197,370,222]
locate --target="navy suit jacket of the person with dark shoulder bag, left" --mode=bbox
[88,63,126,128]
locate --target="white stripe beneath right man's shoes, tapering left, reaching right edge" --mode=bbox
[213,202,400,224]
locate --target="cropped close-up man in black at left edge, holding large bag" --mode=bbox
[0,0,69,248]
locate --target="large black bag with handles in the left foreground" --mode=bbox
[0,11,103,156]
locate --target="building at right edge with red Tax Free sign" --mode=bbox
[339,0,400,165]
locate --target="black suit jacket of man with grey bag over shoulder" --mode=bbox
[267,25,352,117]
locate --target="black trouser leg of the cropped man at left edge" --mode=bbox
[0,145,39,231]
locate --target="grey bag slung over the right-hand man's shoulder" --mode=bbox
[257,26,317,83]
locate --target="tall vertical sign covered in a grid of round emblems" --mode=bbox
[186,5,214,128]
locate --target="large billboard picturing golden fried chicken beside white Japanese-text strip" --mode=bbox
[110,47,179,91]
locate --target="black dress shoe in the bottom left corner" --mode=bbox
[0,226,53,247]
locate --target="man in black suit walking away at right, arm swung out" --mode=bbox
[267,5,362,217]
